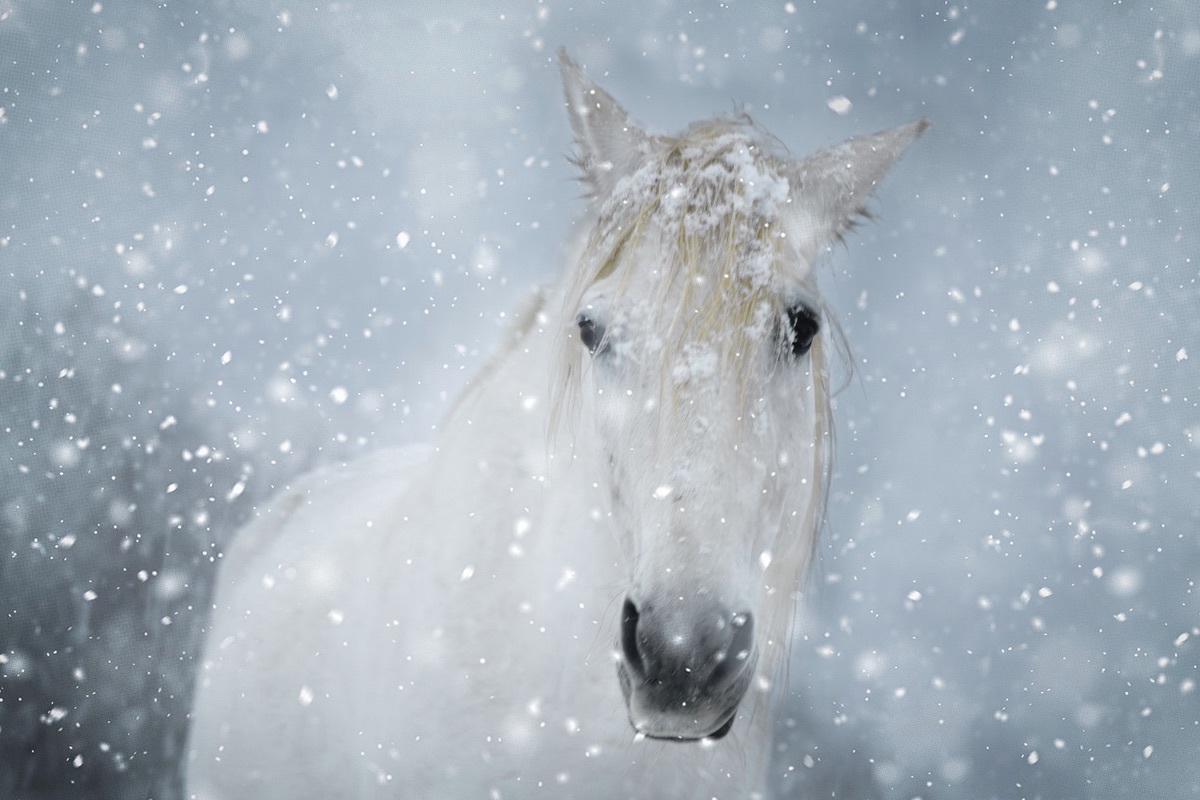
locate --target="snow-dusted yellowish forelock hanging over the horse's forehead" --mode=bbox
[554,114,821,431]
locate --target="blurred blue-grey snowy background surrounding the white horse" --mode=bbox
[0,0,1200,800]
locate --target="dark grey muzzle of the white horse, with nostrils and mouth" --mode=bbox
[617,599,757,740]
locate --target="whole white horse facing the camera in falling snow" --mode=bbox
[186,54,925,800]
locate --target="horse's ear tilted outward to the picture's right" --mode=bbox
[790,120,929,255]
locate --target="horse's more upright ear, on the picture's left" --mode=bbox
[558,48,650,199]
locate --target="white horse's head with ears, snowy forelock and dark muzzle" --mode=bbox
[559,53,925,740]
